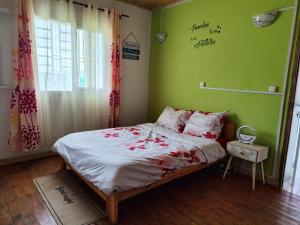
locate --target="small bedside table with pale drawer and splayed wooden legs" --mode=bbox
[223,141,269,191]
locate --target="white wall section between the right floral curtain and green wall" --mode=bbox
[80,0,152,125]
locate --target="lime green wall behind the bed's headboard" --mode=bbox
[149,0,293,178]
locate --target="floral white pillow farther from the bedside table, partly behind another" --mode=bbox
[156,106,192,133]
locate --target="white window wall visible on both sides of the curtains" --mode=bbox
[0,0,152,160]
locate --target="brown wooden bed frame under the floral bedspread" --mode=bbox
[62,122,235,224]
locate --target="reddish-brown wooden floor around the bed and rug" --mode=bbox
[0,157,300,225]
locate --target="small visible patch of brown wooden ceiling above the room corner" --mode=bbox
[118,0,182,10]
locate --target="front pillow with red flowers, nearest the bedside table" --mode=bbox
[183,112,227,139]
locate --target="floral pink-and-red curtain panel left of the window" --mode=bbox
[9,0,40,151]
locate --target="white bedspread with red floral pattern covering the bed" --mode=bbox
[53,123,225,194]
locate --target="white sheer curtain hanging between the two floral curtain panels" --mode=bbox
[34,0,111,147]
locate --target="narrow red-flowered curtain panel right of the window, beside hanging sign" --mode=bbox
[108,9,121,127]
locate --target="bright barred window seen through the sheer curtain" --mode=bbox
[35,18,104,91]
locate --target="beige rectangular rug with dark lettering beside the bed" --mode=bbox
[33,171,105,225]
